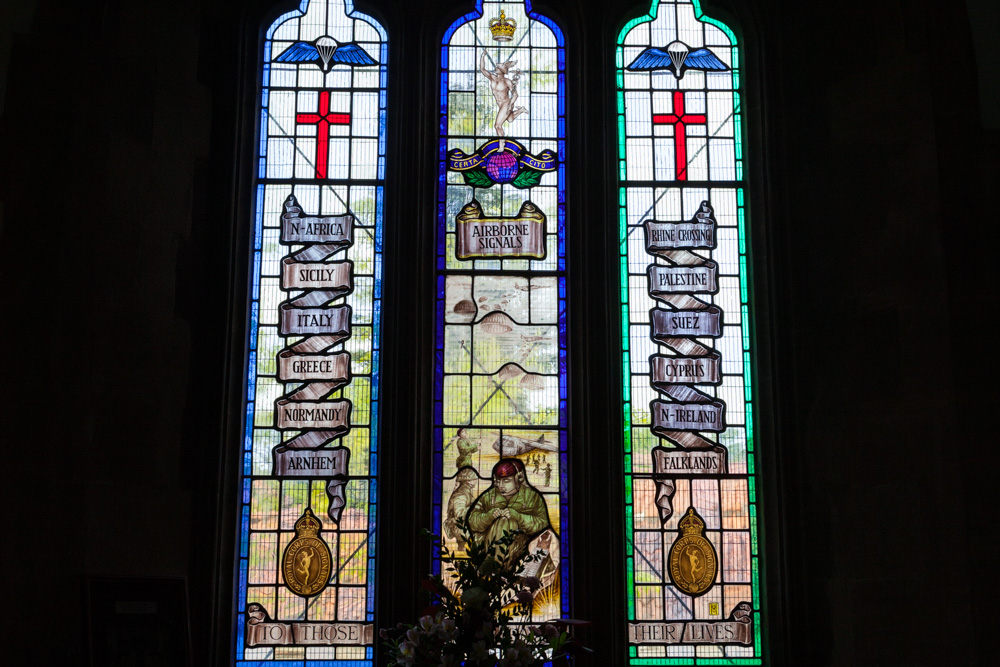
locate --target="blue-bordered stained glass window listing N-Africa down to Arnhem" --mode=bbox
[234,0,387,666]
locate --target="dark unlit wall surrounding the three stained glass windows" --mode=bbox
[0,0,1000,666]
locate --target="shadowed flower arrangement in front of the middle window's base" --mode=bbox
[379,522,587,667]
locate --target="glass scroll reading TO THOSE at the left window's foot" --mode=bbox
[246,602,375,648]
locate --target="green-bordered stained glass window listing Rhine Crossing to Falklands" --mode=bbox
[616,0,763,665]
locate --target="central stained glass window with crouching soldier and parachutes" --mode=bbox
[434,0,569,619]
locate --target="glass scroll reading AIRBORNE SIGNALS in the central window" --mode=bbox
[455,199,545,259]
